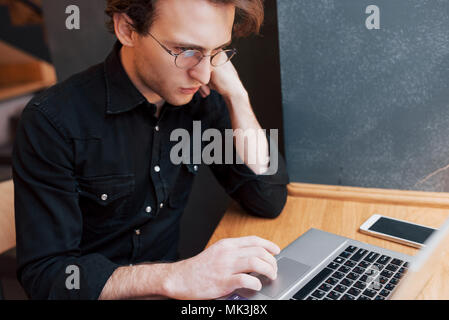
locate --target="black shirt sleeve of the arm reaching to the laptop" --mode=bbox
[13,104,119,299]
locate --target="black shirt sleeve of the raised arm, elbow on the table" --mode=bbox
[205,92,289,218]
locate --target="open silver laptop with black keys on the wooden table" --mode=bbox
[224,215,449,300]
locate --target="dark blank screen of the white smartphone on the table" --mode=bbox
[369,217,435,244]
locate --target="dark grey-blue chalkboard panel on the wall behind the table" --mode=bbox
[277,0,449,191]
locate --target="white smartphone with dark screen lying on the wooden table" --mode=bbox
[360,214,435,248]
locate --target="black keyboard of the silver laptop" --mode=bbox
[291,246,408,300]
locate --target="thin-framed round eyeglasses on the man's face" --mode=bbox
[148,33,237,69]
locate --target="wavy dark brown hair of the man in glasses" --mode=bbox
[105,0,264,37]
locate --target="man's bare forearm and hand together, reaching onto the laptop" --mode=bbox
[100,236,280,299]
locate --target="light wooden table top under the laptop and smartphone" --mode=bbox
[208,183,449,299]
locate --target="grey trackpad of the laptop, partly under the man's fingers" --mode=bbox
[258,258,310,299]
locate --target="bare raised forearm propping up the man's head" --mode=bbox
[224,89,269,174]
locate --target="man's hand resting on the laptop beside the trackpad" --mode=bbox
[161,236,280,299]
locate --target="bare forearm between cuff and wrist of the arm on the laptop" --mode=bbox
[99,263,172,300]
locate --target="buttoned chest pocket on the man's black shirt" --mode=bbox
[78,175,134,231]
